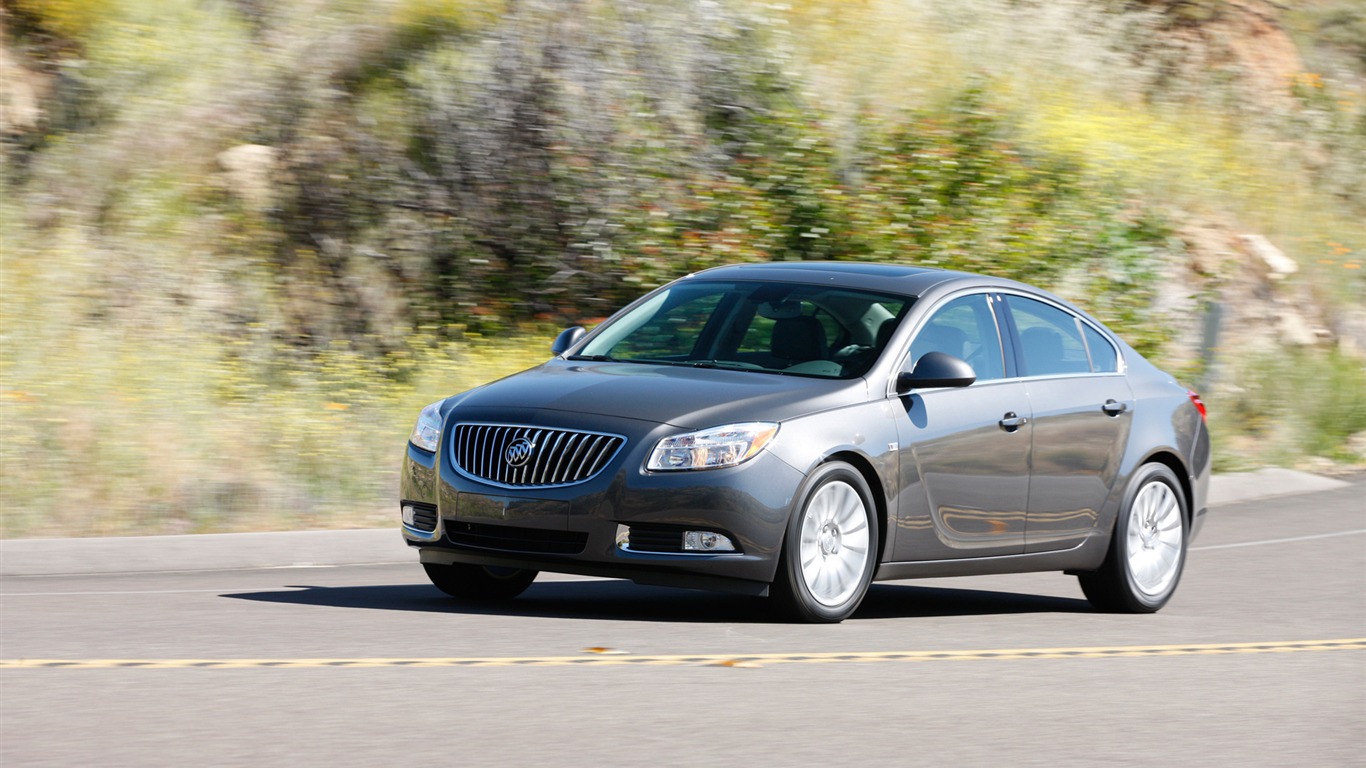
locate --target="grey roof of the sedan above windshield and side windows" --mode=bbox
[688,261,1026,297]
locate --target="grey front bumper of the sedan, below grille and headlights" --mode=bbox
[402,415,803,594]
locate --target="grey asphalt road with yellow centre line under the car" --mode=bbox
[0,478,1366,768]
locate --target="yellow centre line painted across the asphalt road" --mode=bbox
[0,638,1366,670]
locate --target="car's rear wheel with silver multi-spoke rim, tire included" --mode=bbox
[1076,463,1190,614]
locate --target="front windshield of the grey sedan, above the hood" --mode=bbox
[570,280,912,379]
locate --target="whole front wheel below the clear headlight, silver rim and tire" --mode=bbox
[773,462,878,623]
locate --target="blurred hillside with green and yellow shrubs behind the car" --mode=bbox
[0,0,1366,537]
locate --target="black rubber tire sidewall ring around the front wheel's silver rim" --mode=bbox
[779,462,880,623]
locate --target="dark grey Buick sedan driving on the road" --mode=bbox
[400,262,1210,622]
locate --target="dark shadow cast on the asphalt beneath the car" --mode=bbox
[221,579,1093,623]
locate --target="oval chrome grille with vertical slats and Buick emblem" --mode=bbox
[451,424,626,488]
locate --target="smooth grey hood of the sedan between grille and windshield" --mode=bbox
[451,359,867,429]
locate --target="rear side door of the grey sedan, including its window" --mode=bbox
[1005,294,1134,552]
